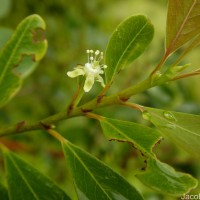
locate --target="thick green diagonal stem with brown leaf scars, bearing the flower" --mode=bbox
[0,78,169,137]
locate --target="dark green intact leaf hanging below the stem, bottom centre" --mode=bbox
[62,140,143,200]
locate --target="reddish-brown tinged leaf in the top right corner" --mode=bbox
[166,0,200,54]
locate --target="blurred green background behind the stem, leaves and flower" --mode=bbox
[0,0,200,200]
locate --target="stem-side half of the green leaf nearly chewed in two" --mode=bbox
[100,117,161,157]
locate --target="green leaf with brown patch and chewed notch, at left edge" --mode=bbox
[0,15,47,107]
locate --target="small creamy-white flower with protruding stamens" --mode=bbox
[67,50,107,92]
